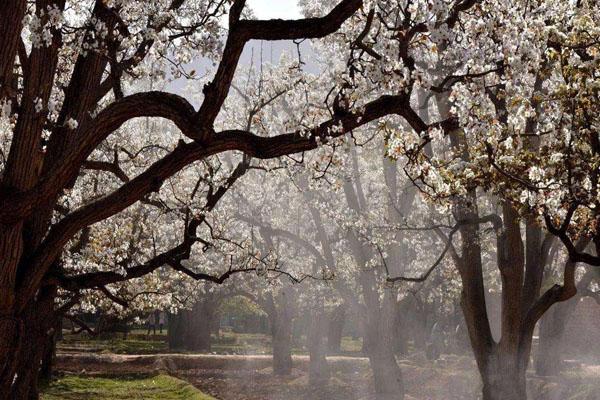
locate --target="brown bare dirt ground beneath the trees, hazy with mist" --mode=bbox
[57,353,600,400]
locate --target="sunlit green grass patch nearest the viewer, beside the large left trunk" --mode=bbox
[41,375,215,400]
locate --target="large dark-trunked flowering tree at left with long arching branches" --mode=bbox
[0,0,506,399]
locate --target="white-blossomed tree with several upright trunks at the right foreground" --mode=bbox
[380,1,598,399]
